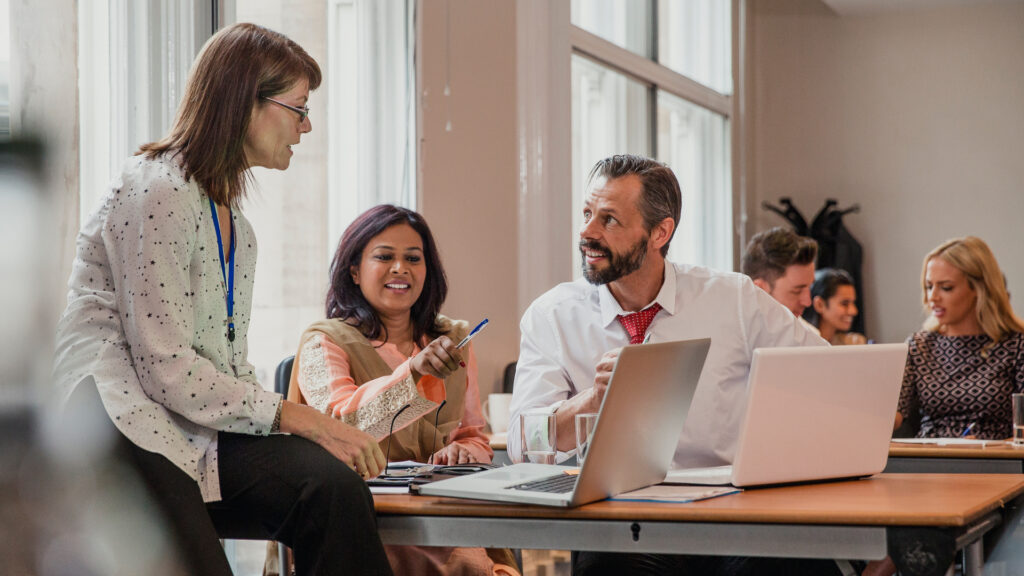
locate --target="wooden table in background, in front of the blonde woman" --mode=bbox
[885,442,1024,474]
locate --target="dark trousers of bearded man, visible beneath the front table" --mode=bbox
[572,551,840,576]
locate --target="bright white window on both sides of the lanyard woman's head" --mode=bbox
[77,0,416,388]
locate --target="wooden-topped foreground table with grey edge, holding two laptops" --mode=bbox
[375,474,1024,575]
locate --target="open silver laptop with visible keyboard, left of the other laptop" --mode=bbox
[420,338,711,506]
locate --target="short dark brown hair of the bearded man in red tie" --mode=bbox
[587,154,683,256]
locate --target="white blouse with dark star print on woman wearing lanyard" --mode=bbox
[54,155,282,502]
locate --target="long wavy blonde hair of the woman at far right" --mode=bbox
[921,236,1024,343]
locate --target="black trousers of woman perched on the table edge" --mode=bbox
[72,379,391,576]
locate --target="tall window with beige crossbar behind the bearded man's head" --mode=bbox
[569,0,733,276]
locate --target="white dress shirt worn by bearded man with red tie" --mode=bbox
[508,261,827,467]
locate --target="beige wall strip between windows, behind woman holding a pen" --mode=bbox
[417,0,519,398]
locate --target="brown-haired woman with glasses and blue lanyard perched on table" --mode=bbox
[55,24,390,575]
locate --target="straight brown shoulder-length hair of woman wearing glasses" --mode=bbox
[137,23,322,205]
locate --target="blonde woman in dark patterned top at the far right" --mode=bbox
[896,236,1024,439]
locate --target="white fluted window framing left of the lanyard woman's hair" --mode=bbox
[78,0,214,223]
